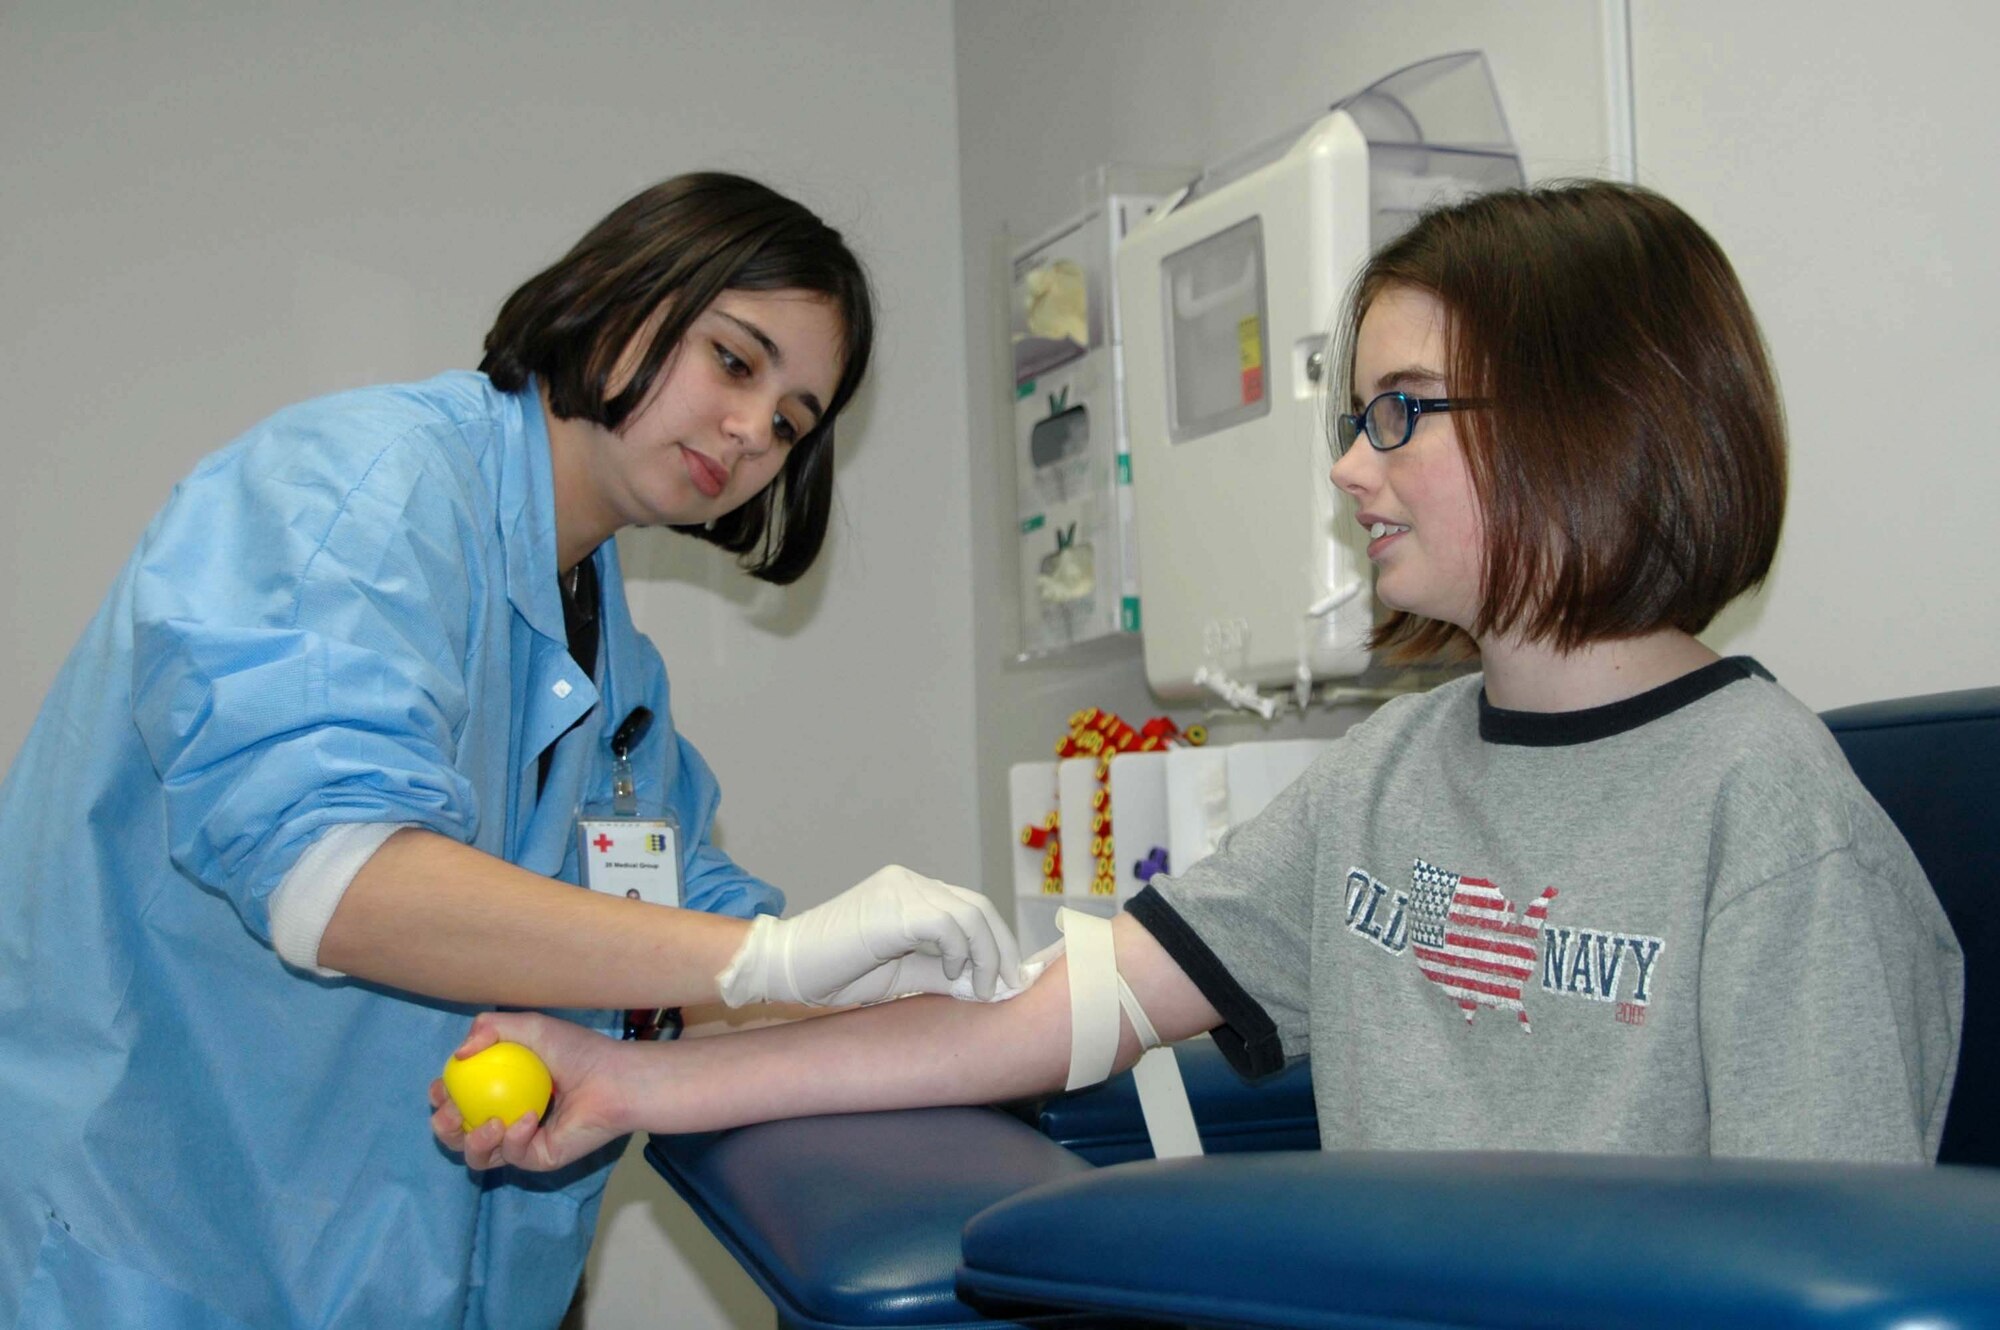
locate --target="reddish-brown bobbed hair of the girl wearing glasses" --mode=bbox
[1328,180,1786,662]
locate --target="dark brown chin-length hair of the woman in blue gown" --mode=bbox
[480,172,874,584]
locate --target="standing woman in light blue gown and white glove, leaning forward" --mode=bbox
[0,174,1018,1326]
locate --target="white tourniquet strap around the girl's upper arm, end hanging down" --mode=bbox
[1056,910,1202,1160]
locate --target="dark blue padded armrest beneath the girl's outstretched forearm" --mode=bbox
[646,1108,1090,1330]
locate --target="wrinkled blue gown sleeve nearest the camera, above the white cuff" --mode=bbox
[132,418,480,942]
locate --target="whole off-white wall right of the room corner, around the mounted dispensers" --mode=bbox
[956,0,2000,904]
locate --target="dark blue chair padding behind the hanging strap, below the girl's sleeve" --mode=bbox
[1024,1038,1320,1166]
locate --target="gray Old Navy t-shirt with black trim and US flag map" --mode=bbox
[1132,658,1964,1160]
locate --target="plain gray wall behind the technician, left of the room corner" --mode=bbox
[0,0,976,1330]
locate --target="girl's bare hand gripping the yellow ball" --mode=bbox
[430,1012,638,1172]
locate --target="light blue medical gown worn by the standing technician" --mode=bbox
[0,374,782,1330]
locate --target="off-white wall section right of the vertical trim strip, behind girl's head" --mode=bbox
[1632,0,2000,708]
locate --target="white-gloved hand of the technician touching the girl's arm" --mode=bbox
[716,864,1024,1006]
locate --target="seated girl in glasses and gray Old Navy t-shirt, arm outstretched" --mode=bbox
[432,182,1962,1170]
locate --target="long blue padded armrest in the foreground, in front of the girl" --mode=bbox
[958,1154,2000,1330]
